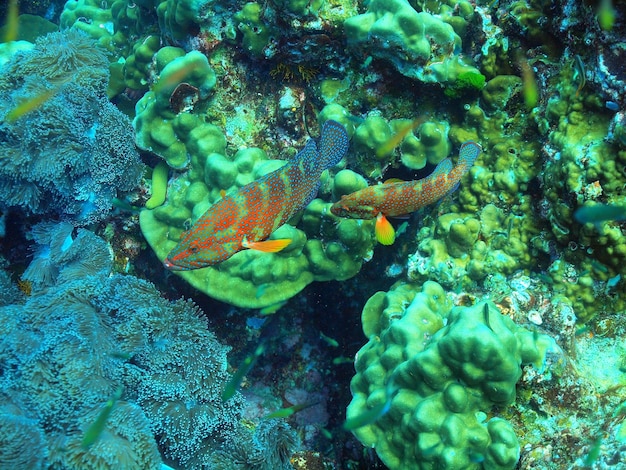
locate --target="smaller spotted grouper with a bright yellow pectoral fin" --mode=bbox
[330,141,481,245]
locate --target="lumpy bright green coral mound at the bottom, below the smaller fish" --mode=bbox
[346,282,554,470]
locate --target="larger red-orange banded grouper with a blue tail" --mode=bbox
[163,121,349,271]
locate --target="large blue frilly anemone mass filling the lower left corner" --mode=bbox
[0,224,298,469]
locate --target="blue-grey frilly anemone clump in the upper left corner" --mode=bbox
[0,30,143,224]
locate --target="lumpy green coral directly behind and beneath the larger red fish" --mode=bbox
[140,137,374,308]
